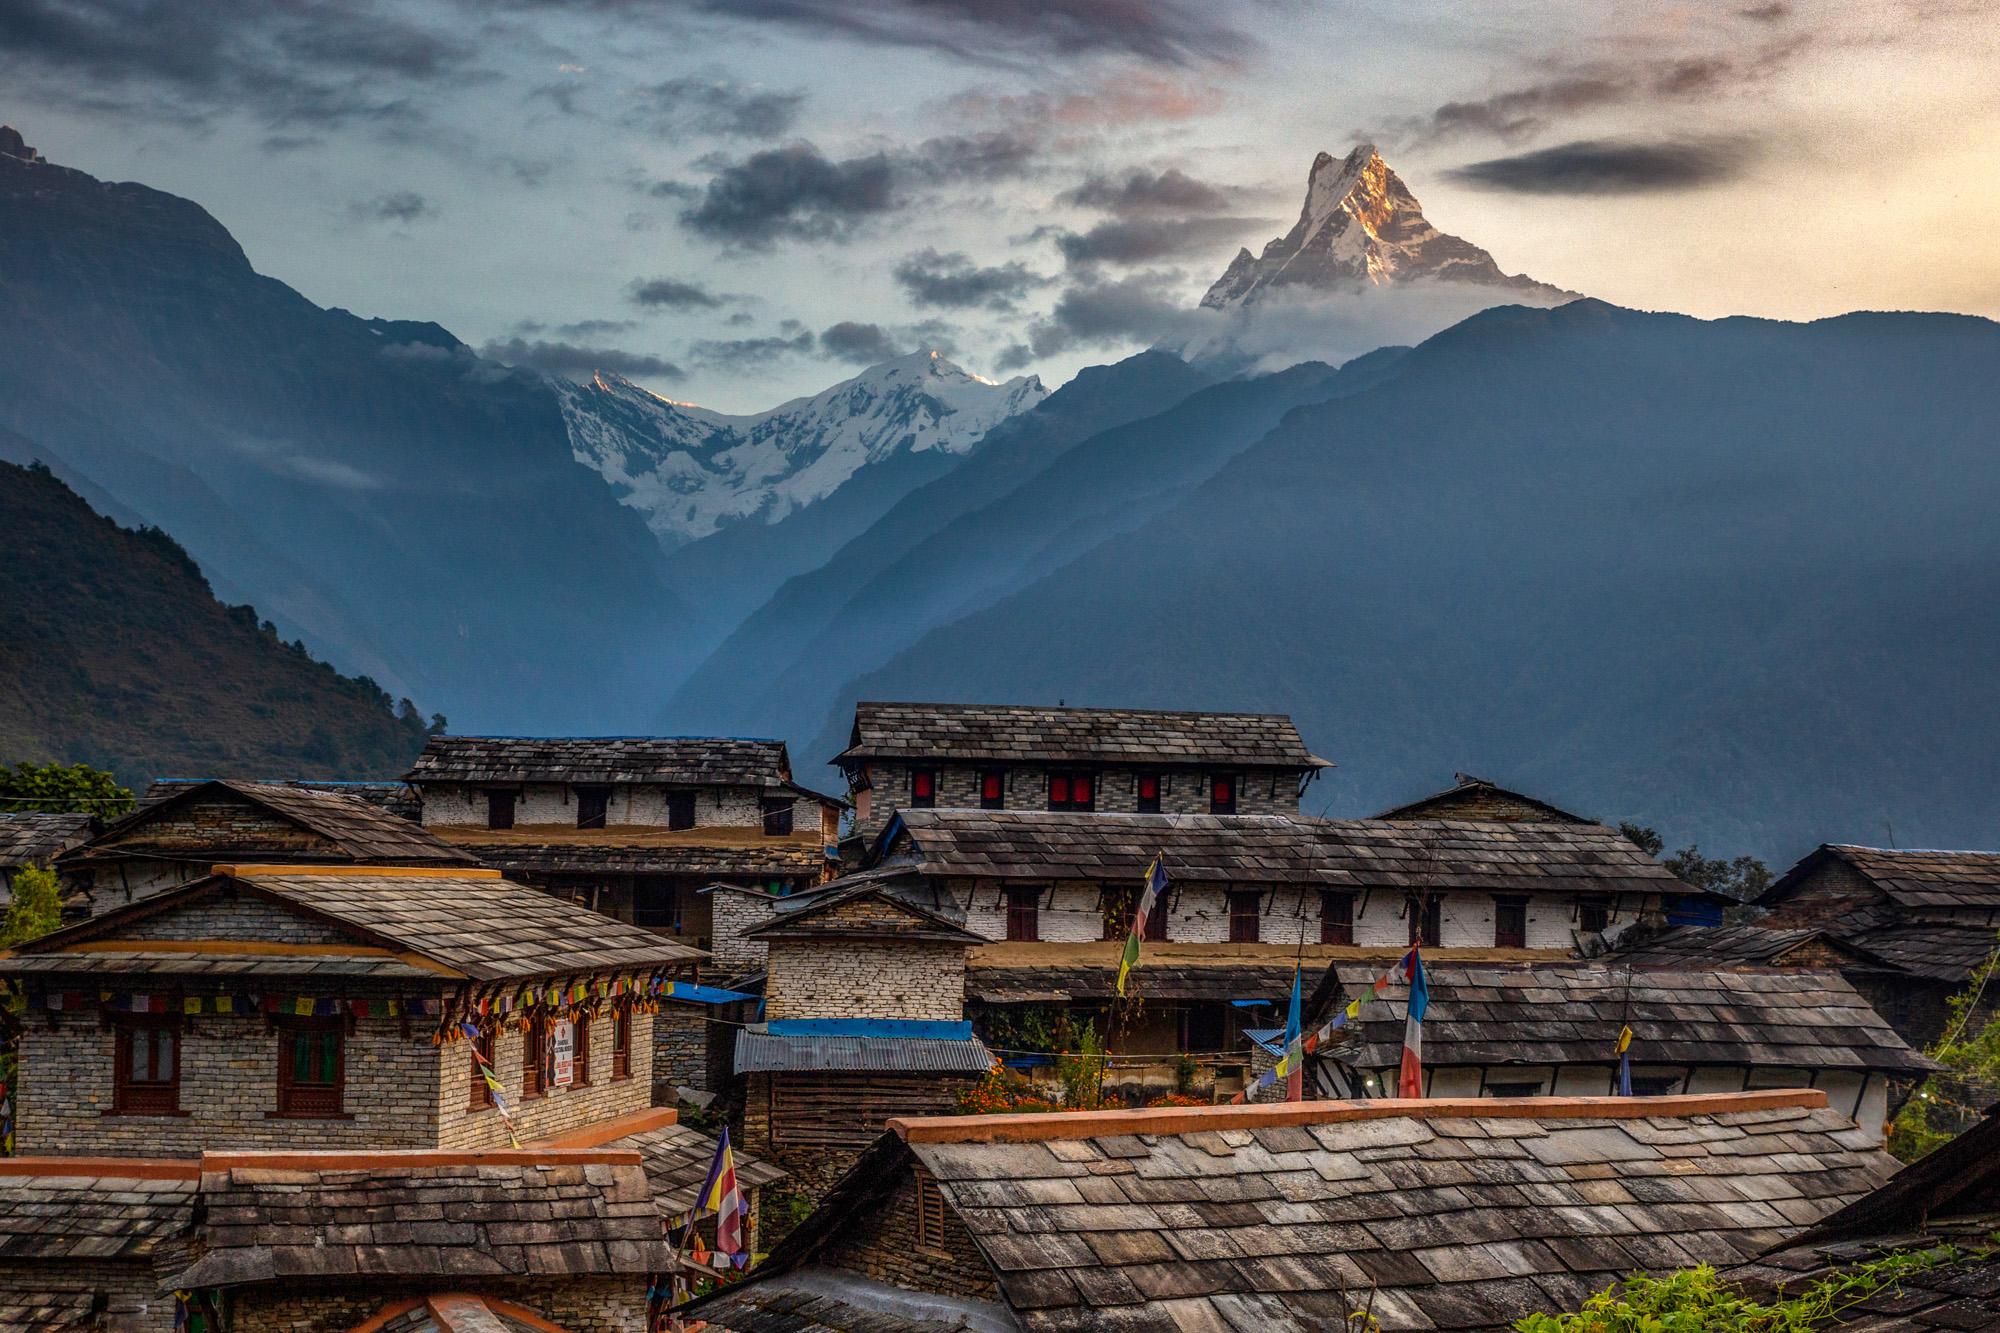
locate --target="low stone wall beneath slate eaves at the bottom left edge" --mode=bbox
[229,1273,646,1333]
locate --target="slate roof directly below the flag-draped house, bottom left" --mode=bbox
[168,1153,672,1287]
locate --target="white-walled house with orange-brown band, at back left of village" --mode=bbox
[406,737,844,949]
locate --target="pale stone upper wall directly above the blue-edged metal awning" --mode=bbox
[764,939,966,1023]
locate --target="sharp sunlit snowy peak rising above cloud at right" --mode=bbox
[1202,144,1576,310]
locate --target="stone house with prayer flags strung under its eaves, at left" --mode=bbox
[0,867,700,1157]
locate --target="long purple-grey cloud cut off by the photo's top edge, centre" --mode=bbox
[656,0,1250,66]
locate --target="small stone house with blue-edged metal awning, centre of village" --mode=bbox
[734,881,992,1197]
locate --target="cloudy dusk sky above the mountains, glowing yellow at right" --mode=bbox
[0,0,2000,412]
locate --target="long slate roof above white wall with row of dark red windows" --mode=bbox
[884,809,1692,893]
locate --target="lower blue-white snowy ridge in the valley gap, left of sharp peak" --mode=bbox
[554,352,1048,550]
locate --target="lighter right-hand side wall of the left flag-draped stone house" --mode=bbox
[426,1011,654,1149]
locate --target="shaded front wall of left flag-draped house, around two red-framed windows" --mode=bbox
[16,1013,438,1157]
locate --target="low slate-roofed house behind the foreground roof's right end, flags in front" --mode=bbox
[1310,963,1938,1139]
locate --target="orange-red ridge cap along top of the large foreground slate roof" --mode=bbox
[888,1087,1826,1143]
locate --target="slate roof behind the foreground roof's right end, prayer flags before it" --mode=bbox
[1322,965,1938,1073]
